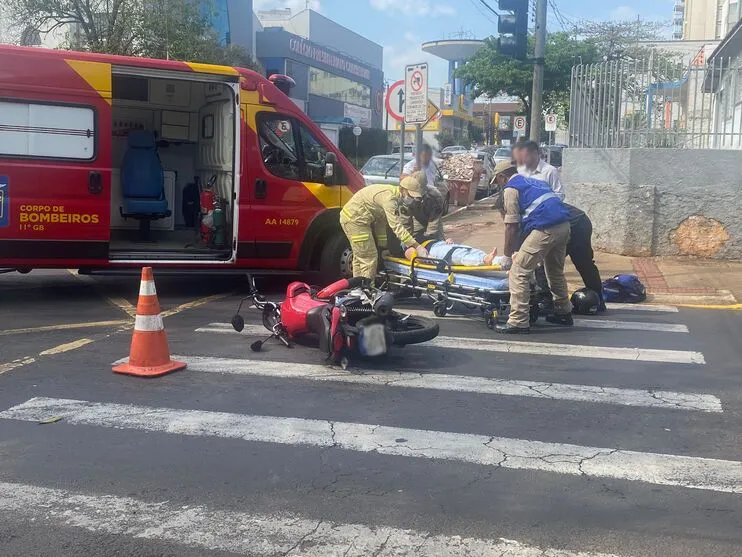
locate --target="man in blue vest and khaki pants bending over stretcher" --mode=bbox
[495,161,574,334]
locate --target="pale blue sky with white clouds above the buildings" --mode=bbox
[253,0,674,87]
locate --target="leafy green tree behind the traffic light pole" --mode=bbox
[457,32,599,119]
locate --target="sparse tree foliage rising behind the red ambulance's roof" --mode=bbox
[6,0,258,68]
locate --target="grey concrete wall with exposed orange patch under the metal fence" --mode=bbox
[562,148,742,259]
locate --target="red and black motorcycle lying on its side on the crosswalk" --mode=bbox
[232,277,439,367]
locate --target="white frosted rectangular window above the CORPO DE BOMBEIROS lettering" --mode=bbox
[0,102,95,160]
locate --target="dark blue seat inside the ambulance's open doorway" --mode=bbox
[120,130,171,239]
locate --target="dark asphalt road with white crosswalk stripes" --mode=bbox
[0,271,742,557]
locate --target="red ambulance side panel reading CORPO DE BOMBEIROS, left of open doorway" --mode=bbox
[0,50,111,267]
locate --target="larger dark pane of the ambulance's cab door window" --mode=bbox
[258,113,301,180]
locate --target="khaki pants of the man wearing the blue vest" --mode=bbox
[508,222,572,328]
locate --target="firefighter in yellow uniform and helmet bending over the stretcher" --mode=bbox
[340,172,428,279]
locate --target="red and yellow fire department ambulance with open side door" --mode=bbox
[0,45,363,279]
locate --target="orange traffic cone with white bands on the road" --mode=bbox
[113,267,186,377]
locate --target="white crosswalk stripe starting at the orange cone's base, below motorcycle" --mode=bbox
[173,356,723,413]
